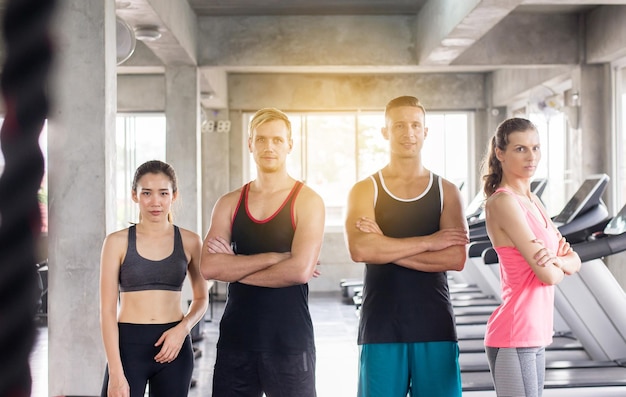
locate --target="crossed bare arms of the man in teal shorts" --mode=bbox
[345,179,467,271]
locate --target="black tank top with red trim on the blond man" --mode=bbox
[217,182,314,353]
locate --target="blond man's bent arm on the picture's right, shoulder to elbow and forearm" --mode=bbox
[240,186,325,288]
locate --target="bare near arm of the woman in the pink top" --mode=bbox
[485,193,571,285]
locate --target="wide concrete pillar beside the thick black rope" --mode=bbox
[48,0,116,396]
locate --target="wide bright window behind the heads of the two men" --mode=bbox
[243,112,474,228]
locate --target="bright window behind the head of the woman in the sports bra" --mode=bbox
[115,114,166,229]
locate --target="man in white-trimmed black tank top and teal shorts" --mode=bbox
[345,96,468,397]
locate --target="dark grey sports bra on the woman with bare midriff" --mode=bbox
[119,225,187,292]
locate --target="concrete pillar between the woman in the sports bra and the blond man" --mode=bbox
[165,66,201,233]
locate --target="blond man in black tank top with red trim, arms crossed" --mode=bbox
[201,108,324,397]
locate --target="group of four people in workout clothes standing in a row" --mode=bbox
[100,96,580,397]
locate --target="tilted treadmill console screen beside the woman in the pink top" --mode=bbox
[552,174,609,226]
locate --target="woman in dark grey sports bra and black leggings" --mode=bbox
[100,160,208,397]
